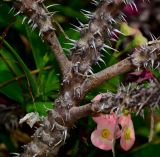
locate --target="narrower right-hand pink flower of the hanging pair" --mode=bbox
[119,114,135,151]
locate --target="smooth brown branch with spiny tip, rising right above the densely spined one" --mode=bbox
[86,40,160,91]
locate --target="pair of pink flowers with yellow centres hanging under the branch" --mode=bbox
[91,113,135,151]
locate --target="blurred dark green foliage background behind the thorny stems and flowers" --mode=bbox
[0,0,160,157]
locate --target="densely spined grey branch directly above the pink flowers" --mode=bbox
[70,81,160,121]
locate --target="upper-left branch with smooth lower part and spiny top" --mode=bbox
[14,0,70,74]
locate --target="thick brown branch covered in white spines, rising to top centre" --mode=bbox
[70,0,124,75]
